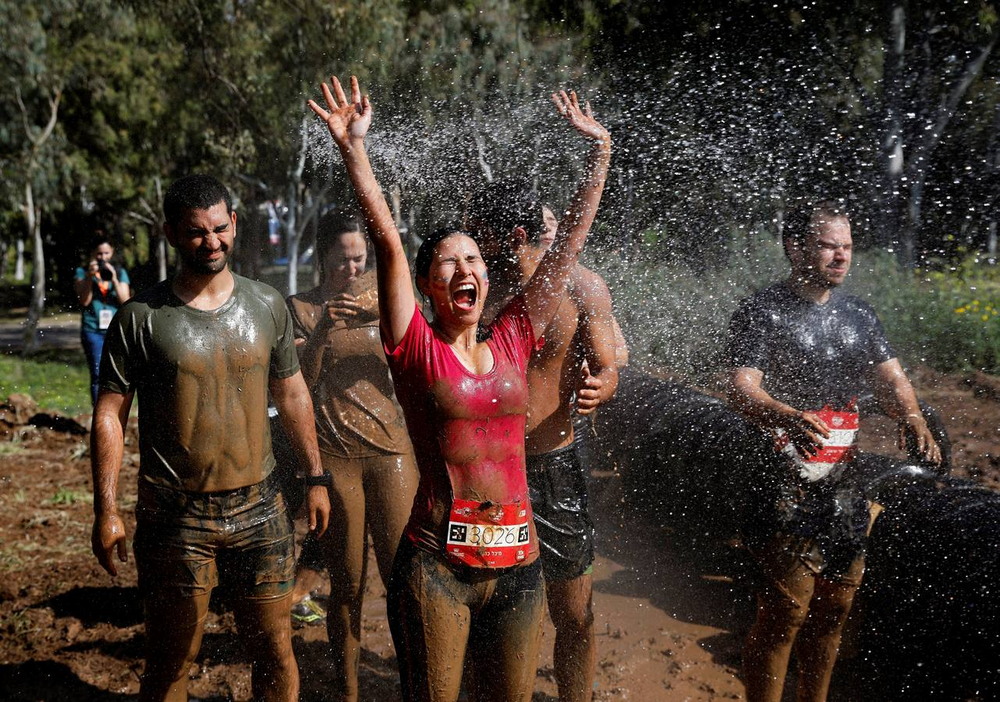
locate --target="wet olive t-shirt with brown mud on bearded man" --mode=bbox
[100,275,299,492]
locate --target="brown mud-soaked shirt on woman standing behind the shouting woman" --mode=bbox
[288,273,411,458]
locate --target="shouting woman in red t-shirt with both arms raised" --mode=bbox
[309,77,611,702]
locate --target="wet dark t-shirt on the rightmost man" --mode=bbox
[726,282,896,410]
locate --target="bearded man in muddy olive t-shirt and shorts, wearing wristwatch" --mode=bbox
[91,175,330,702]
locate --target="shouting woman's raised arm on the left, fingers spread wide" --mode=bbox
[309,76,416,344]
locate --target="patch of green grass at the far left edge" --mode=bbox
[0,349,91,416]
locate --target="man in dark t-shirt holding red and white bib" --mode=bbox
[727,201,941,702]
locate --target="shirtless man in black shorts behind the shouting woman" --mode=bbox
[469,181,618,702]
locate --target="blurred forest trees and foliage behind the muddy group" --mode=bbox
[0,0,1000,370]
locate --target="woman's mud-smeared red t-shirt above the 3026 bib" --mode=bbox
[383,297,538,565]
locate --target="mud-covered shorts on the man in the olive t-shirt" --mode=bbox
[133,478,295,599]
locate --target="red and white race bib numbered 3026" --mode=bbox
[445,499,532,568]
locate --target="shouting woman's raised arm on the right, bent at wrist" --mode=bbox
[524,91,611,335]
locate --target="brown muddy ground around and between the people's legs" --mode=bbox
[0,370,1000,702]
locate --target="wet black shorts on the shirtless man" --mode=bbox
[527,445,594,580]
